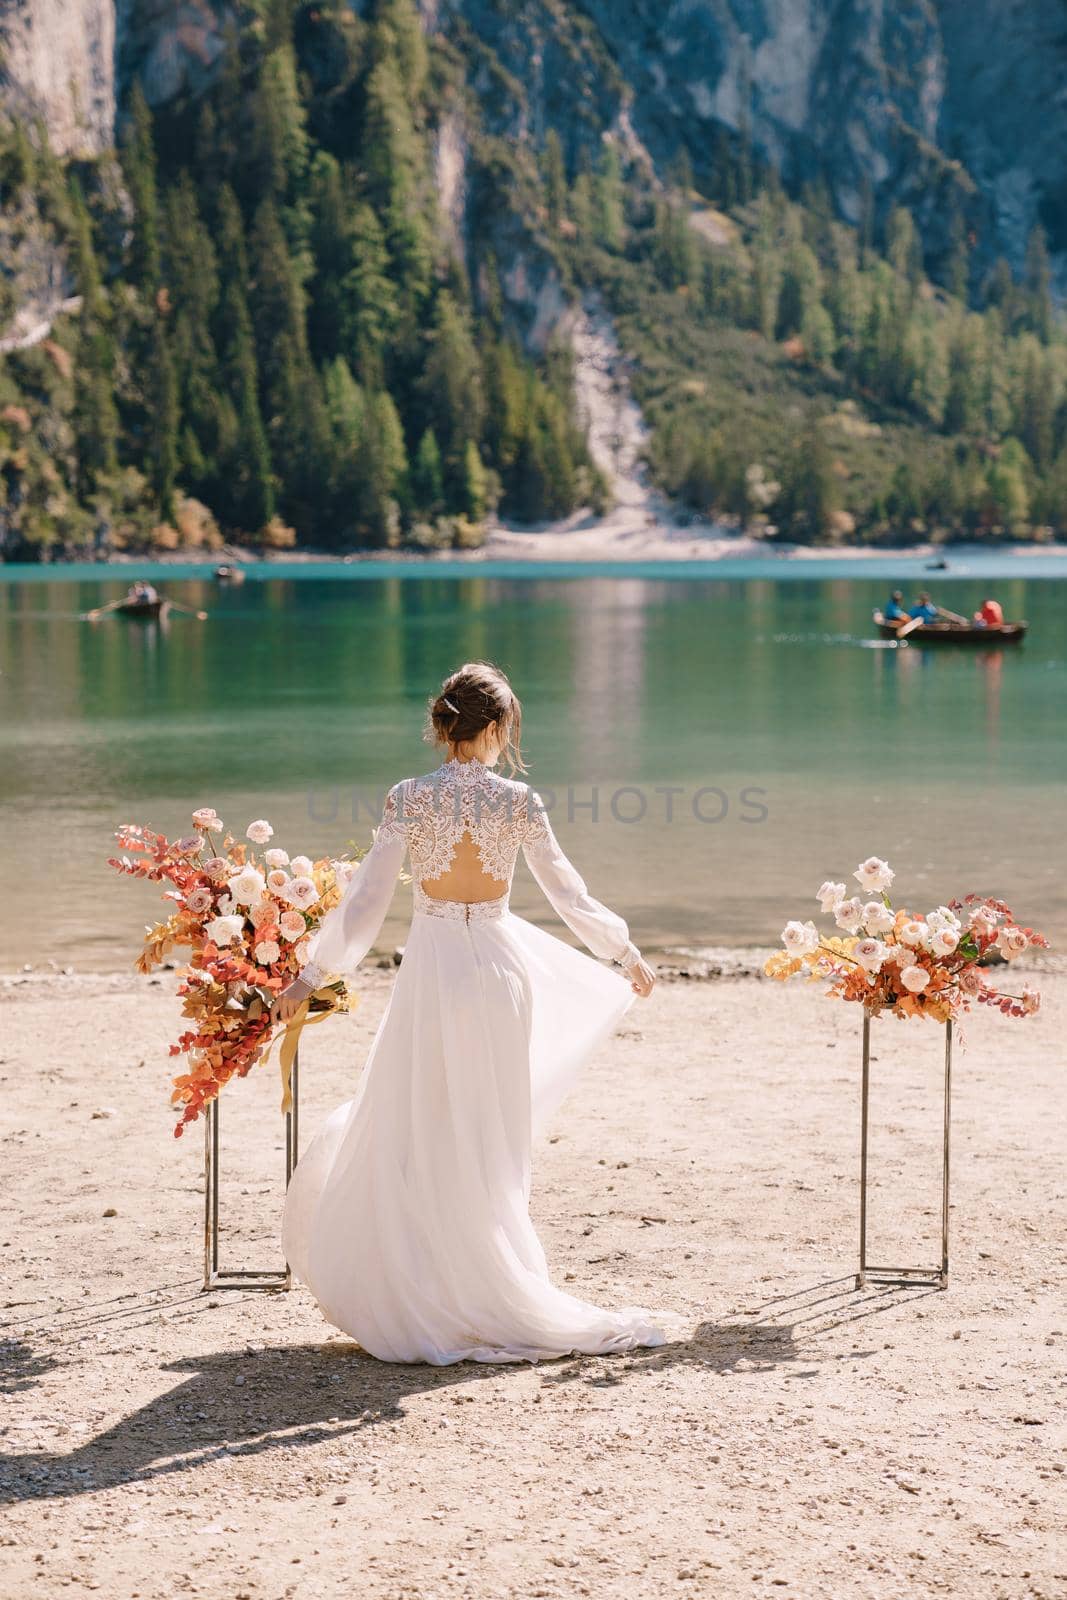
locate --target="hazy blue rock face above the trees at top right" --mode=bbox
[451,0,1067,277]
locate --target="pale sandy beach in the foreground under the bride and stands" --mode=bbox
[0,960,1067,1600]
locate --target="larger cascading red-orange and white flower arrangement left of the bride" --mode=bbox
[107,806,357,1138]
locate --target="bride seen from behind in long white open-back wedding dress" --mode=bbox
[272,662,664,1365]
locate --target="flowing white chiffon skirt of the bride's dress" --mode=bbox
[282,909,664,1365]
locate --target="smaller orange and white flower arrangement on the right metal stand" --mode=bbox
[763,856,1048,1022]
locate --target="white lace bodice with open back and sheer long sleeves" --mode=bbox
[301,760,640,987]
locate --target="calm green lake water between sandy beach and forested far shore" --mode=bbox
[0,558,1067,970]
